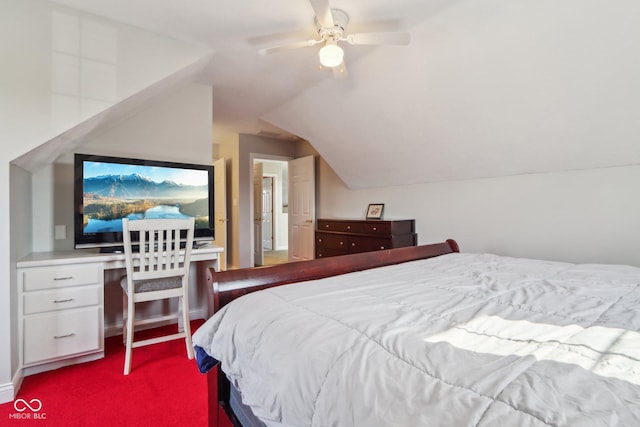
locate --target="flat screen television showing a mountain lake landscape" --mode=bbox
[74,154,214,251]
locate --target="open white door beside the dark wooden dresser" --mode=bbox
[289,156,316,261]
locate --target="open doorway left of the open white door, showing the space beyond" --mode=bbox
[253,158,289,265]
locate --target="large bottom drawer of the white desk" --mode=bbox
[23,307,102,365]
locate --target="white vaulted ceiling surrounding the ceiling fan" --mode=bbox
[48,0,640,188]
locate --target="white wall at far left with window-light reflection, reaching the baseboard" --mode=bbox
[0,0,210,403]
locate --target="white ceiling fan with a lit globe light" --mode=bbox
[258,0,411,77]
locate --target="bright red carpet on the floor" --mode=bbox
[0,320,207,427]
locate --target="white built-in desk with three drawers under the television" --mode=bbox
[16,245,223,375]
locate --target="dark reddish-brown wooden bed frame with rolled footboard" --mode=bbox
[207,239,459,427]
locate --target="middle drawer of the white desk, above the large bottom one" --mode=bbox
[22,285,102,314]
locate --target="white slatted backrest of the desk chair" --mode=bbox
[122,218,194,286]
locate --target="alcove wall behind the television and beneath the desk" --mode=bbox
[33,84,212,333]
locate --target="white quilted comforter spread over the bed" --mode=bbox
[193,254,640,427]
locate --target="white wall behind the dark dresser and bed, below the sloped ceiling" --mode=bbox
[317,141,640,266]
